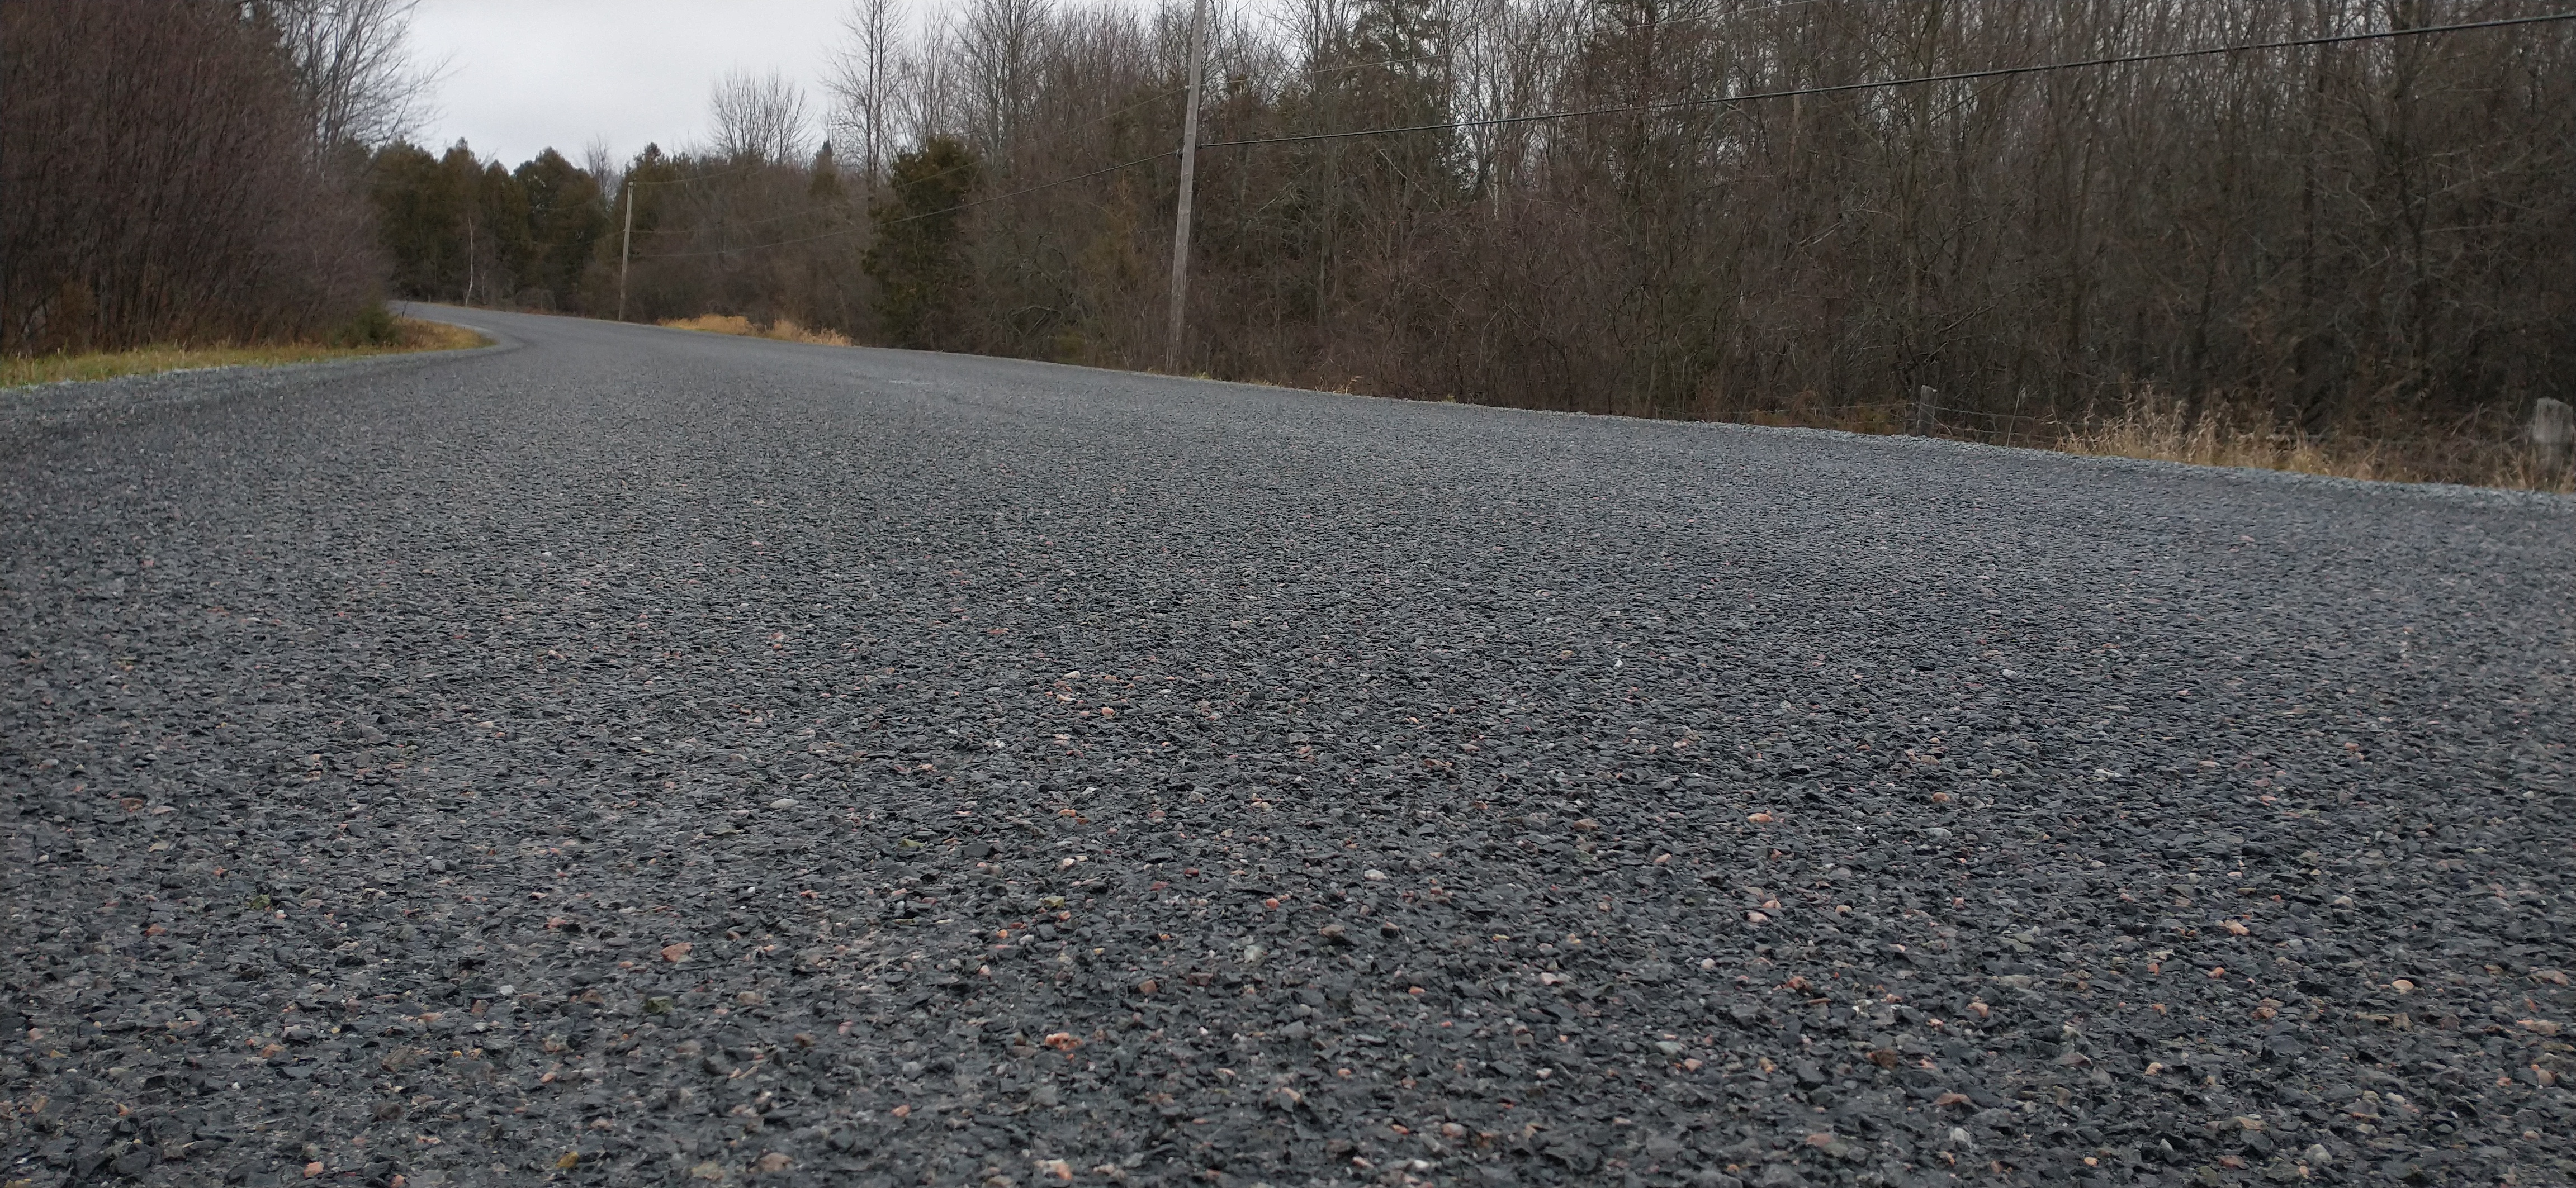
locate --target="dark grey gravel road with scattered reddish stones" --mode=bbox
[0,312,2576,1188]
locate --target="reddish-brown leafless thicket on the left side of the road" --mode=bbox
[0,0,423,353]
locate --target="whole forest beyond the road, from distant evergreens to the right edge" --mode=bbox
[8,0,2576,482]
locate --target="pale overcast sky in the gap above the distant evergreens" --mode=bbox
[412,0,845,165]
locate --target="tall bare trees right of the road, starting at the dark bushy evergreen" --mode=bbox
[814,0,2576,435]
